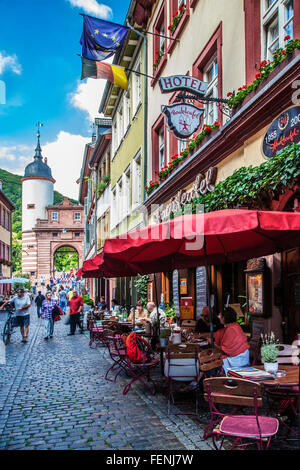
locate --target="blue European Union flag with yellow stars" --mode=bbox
[80,15,129,60]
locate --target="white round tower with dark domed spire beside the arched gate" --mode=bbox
[21,133,55,277]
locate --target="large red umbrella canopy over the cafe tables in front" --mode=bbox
[103,209,300,275]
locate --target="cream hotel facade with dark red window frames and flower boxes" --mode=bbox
[127,0,300,346]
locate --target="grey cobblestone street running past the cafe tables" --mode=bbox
[0,307,212,450]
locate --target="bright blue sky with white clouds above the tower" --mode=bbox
[0,0,130,197]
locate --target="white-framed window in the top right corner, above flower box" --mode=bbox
[262,0,294,60]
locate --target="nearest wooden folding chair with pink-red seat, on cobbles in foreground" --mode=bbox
[203,377,279,450]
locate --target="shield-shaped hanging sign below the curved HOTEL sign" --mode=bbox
[162,103,204,139]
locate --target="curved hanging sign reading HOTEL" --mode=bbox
[159,75,208,95]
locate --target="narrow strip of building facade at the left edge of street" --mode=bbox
[0,181,15,294]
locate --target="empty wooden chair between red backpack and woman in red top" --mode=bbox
[164,343,200,415]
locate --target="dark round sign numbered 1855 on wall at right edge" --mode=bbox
[263,106,300,158]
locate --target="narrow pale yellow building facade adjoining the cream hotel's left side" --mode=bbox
[99,23,148,308]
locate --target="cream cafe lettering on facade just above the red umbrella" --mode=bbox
[154,167,218,223]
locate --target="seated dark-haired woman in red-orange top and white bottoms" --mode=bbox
[214,307,250,375]
